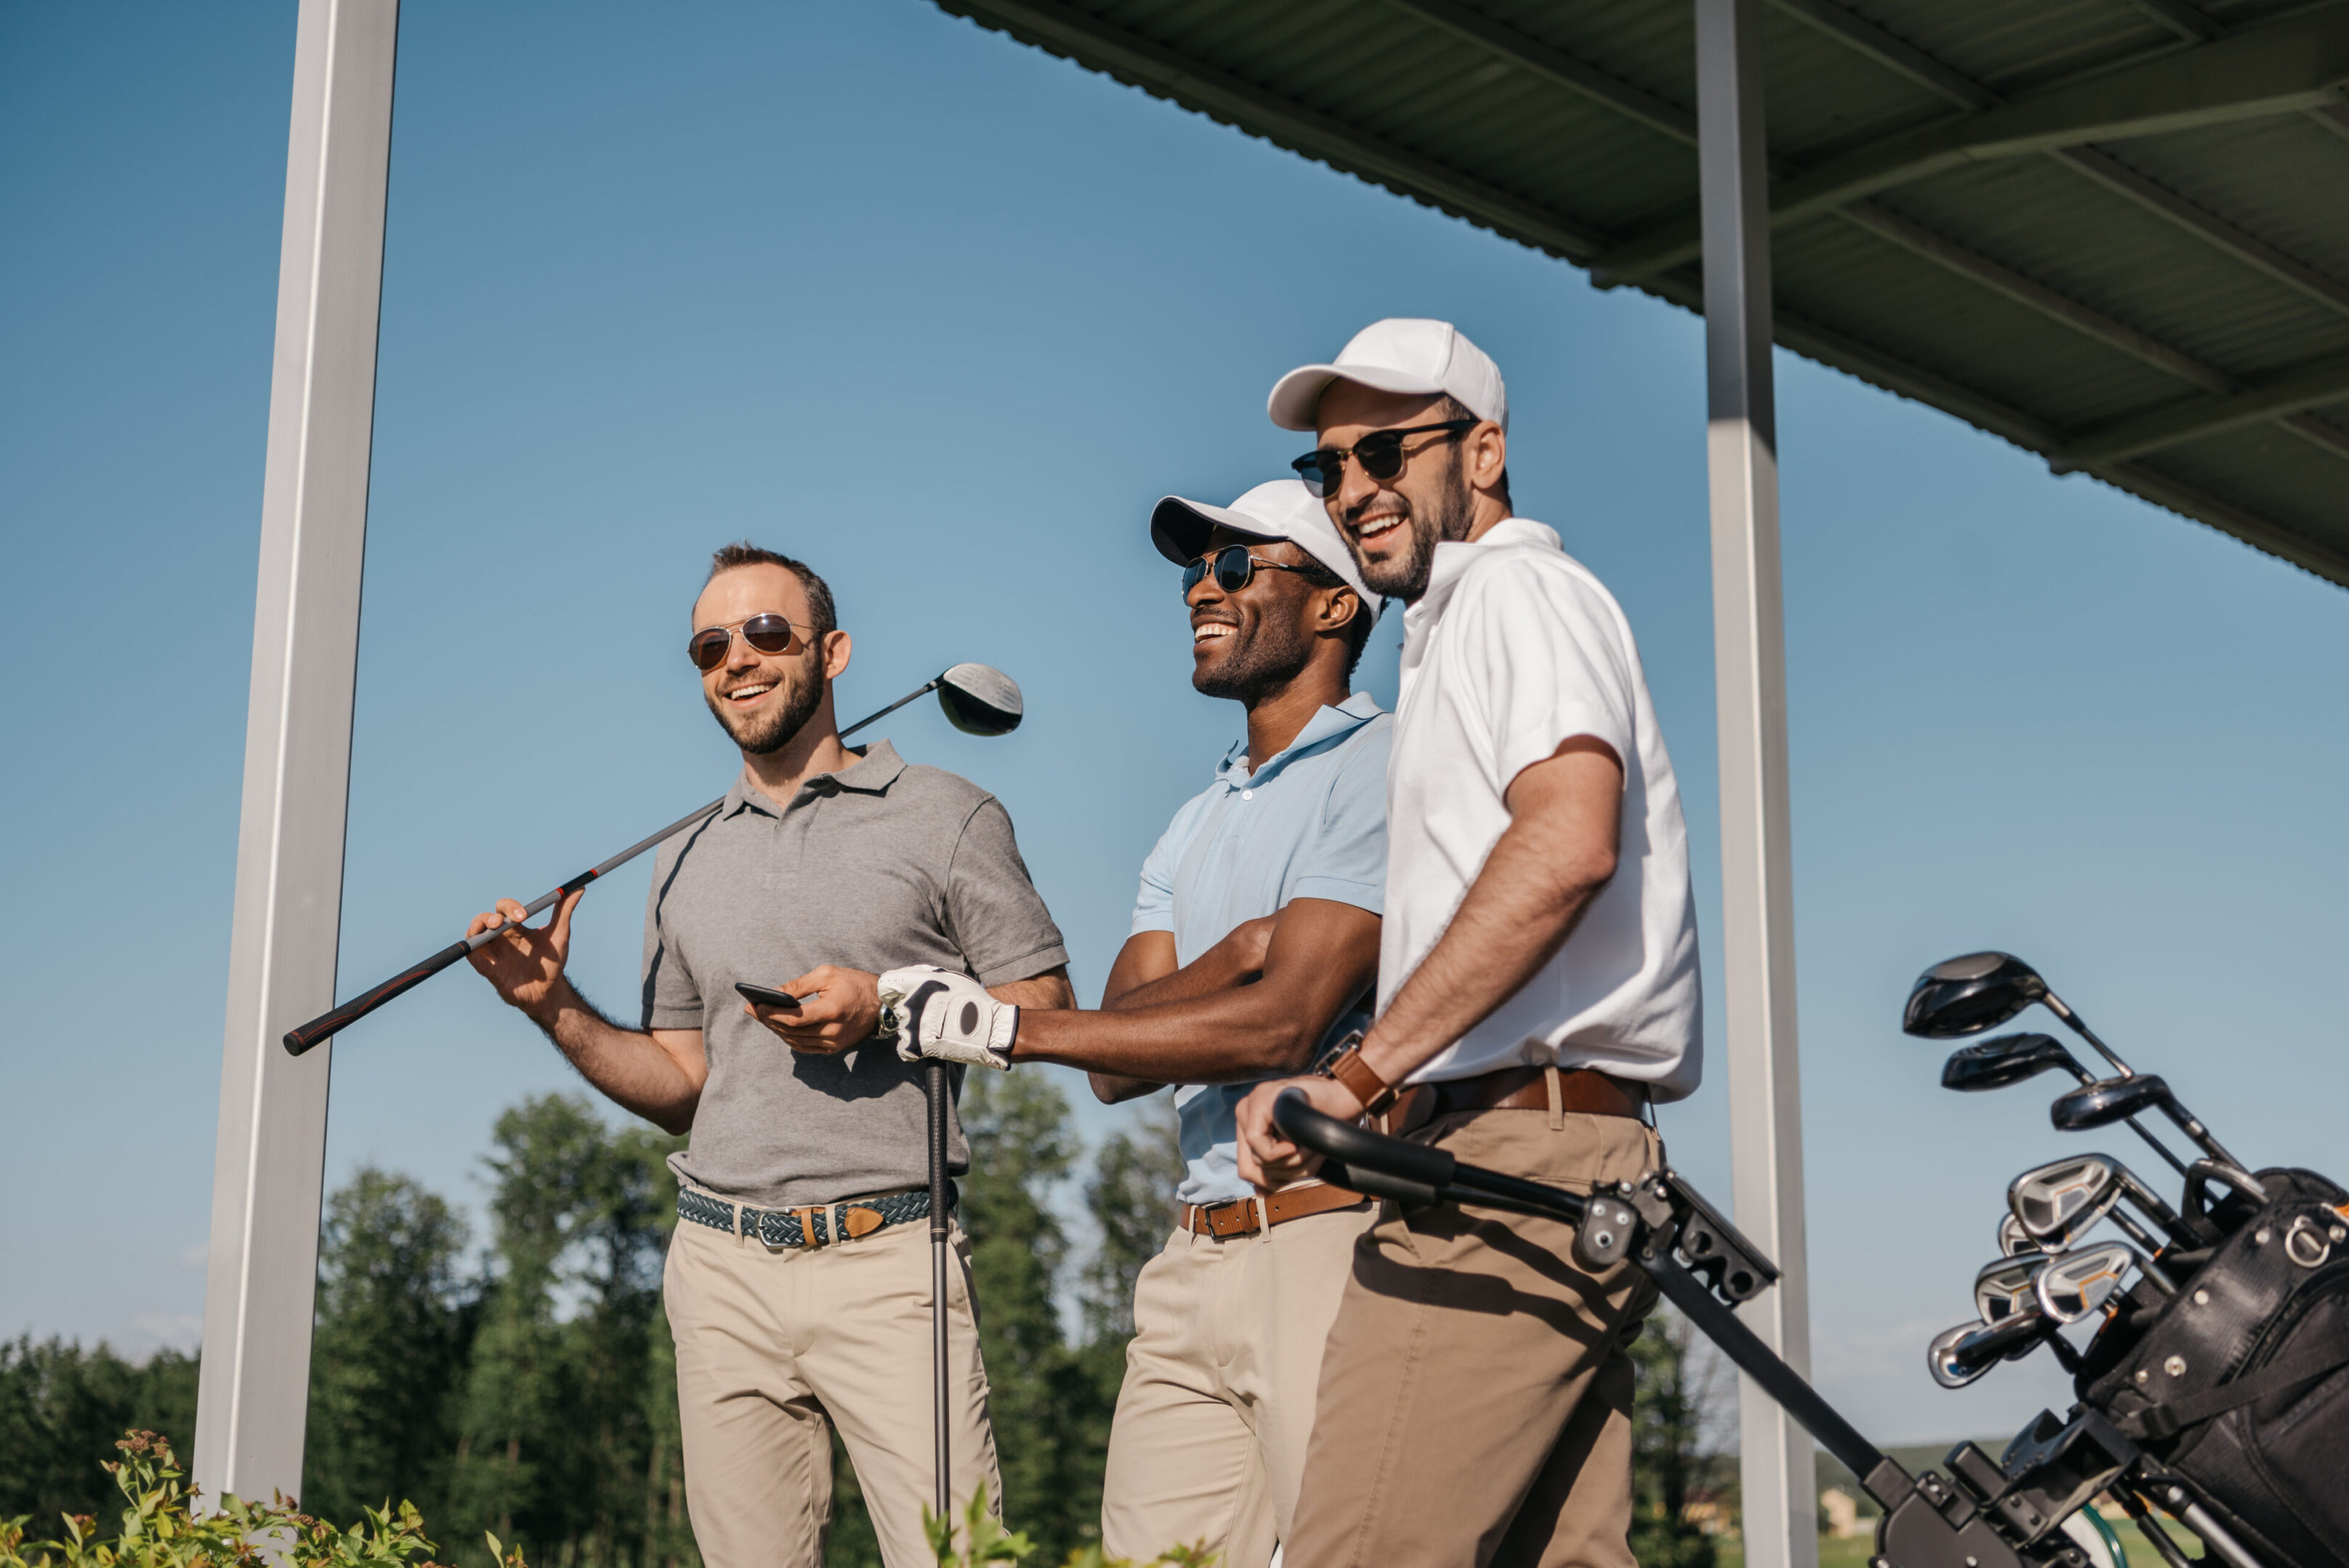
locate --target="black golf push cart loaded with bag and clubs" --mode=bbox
[1273,952,2349,1568]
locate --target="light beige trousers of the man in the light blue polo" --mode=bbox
[1102,1204,1376,1568]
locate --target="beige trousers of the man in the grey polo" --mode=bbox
[663,1220,1003,1568]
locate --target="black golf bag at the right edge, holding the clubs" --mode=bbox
[2077,1171,2349,1568]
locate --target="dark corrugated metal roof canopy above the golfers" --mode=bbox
[935,0,2349,583]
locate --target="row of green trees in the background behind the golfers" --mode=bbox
[0,1074,1724,1568]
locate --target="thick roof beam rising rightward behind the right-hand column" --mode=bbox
[1593,4,2349,282]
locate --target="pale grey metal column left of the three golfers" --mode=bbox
[195,0,399,1498]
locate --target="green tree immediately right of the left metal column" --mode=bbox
[301,1168,477,1521]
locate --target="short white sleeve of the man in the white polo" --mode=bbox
[1461,562,1635,792]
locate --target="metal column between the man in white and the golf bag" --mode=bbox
[1696,0,1818,1568]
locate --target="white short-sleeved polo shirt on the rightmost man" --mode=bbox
[1379,517,1703,1101]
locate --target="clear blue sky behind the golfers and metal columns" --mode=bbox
[0,0,2349,1441]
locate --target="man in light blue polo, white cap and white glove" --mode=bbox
[881,480,1393,1568]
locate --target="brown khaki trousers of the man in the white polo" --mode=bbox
[1285,1110,1663,1568]
